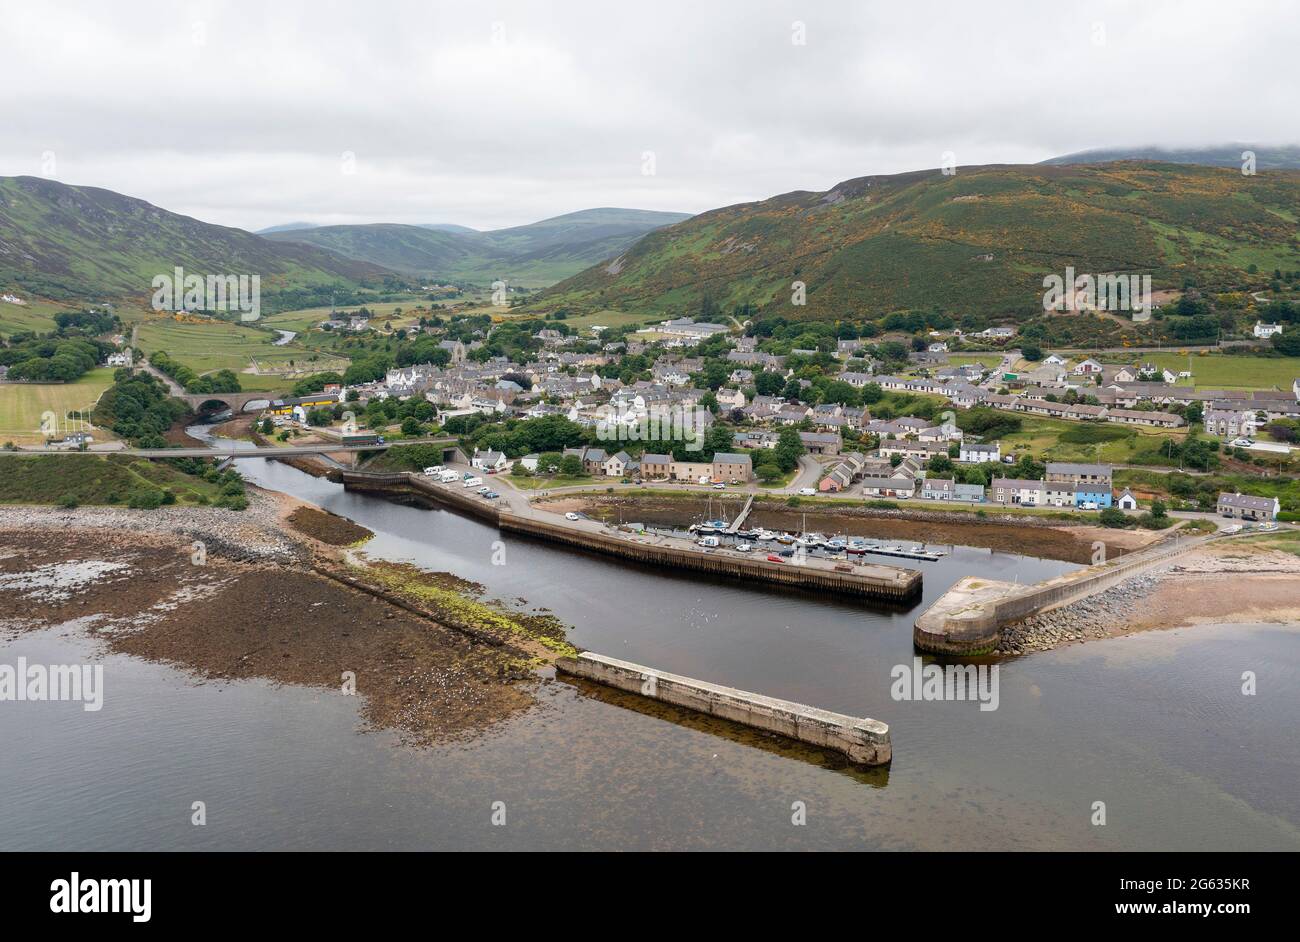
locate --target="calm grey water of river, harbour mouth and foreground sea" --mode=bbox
[0,436,1300,850]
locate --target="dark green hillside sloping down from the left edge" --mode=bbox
[0,177,395,304]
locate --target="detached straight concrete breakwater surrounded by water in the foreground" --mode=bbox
[555,651,893,765]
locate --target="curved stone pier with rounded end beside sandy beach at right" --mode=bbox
[911,537,1214,655]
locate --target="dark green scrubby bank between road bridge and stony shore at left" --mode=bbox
[0,455,218,504]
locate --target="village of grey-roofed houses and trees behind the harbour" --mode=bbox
[200,310,1300,522]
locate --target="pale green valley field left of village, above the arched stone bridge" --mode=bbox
[139,318,347,390]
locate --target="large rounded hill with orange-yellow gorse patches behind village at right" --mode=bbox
[528,162,1300,318]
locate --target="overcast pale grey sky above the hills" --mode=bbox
[0,0,1300,229]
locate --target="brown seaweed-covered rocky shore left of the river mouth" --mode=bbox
[0,489,553,745]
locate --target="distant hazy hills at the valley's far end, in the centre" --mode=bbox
[258,208,689,287]
